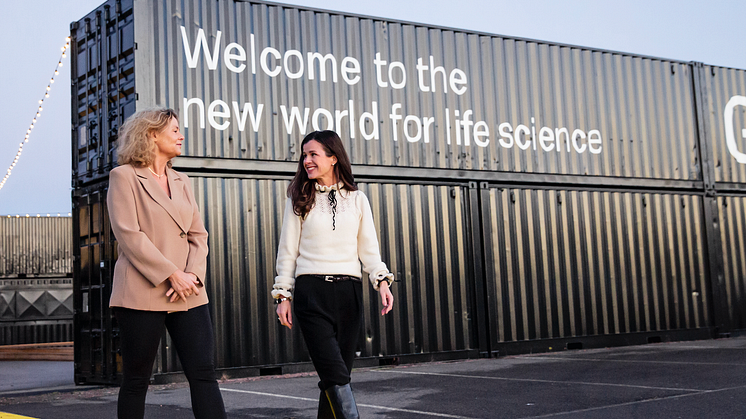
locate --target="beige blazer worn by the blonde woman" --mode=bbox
[106,164,207,311]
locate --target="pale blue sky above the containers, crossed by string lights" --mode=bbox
[0,0,746,216]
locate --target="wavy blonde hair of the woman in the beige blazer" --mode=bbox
[117,108,179,167]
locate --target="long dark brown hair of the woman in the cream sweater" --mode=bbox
[288,130,357,218]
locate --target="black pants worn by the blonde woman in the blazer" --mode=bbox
[114,305,226,419]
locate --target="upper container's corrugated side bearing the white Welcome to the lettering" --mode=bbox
[94,0,701,180]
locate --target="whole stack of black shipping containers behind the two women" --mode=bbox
[71,0,746,382]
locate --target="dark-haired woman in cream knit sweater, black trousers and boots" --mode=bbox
[272,131,394,419]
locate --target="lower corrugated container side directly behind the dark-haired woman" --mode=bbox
[147,177,474,373]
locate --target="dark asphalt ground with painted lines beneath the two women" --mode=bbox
[0,337,746,419]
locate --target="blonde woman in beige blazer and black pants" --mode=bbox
[106,109,225,419]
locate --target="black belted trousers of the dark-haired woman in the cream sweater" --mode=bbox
[293,275,363,391]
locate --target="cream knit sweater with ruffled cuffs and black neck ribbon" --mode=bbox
[272,183,394,298]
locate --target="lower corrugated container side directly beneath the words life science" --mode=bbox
[482,188,710,344]
